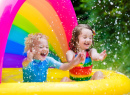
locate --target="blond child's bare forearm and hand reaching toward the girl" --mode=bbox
[59,52,85,70]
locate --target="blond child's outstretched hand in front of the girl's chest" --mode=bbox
[71,51,85,66]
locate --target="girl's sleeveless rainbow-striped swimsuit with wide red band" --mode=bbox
[69,52,93,81]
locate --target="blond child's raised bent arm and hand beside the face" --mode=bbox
[22,50,34,67]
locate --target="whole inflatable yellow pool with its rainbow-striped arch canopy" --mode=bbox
[0,0,130,95]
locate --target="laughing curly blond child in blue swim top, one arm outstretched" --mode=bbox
[22,33,84,82]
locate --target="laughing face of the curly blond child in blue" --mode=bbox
[32,38,49,61]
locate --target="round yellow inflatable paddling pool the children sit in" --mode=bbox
[0,68,130,95]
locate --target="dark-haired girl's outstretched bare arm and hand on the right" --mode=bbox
[90,48,107,61]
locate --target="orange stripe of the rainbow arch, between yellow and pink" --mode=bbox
[27,0,68,58]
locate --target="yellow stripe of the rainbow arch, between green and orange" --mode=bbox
[18,2,66,62]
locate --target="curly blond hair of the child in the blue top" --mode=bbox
[24,33,48,52]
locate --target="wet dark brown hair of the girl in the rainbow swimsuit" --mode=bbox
[69,24,94,53]
